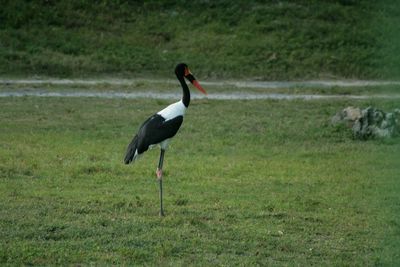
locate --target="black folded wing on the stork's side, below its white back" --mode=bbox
[137,114,183,154]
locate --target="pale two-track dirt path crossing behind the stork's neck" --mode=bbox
[0,79,400,100]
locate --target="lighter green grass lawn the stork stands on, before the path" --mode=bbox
[0,91,400,266]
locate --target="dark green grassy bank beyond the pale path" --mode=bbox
[0,0,400,80]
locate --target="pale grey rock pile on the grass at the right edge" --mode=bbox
[332,107,400,140]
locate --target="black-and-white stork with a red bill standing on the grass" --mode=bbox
[124,63,207,216]
